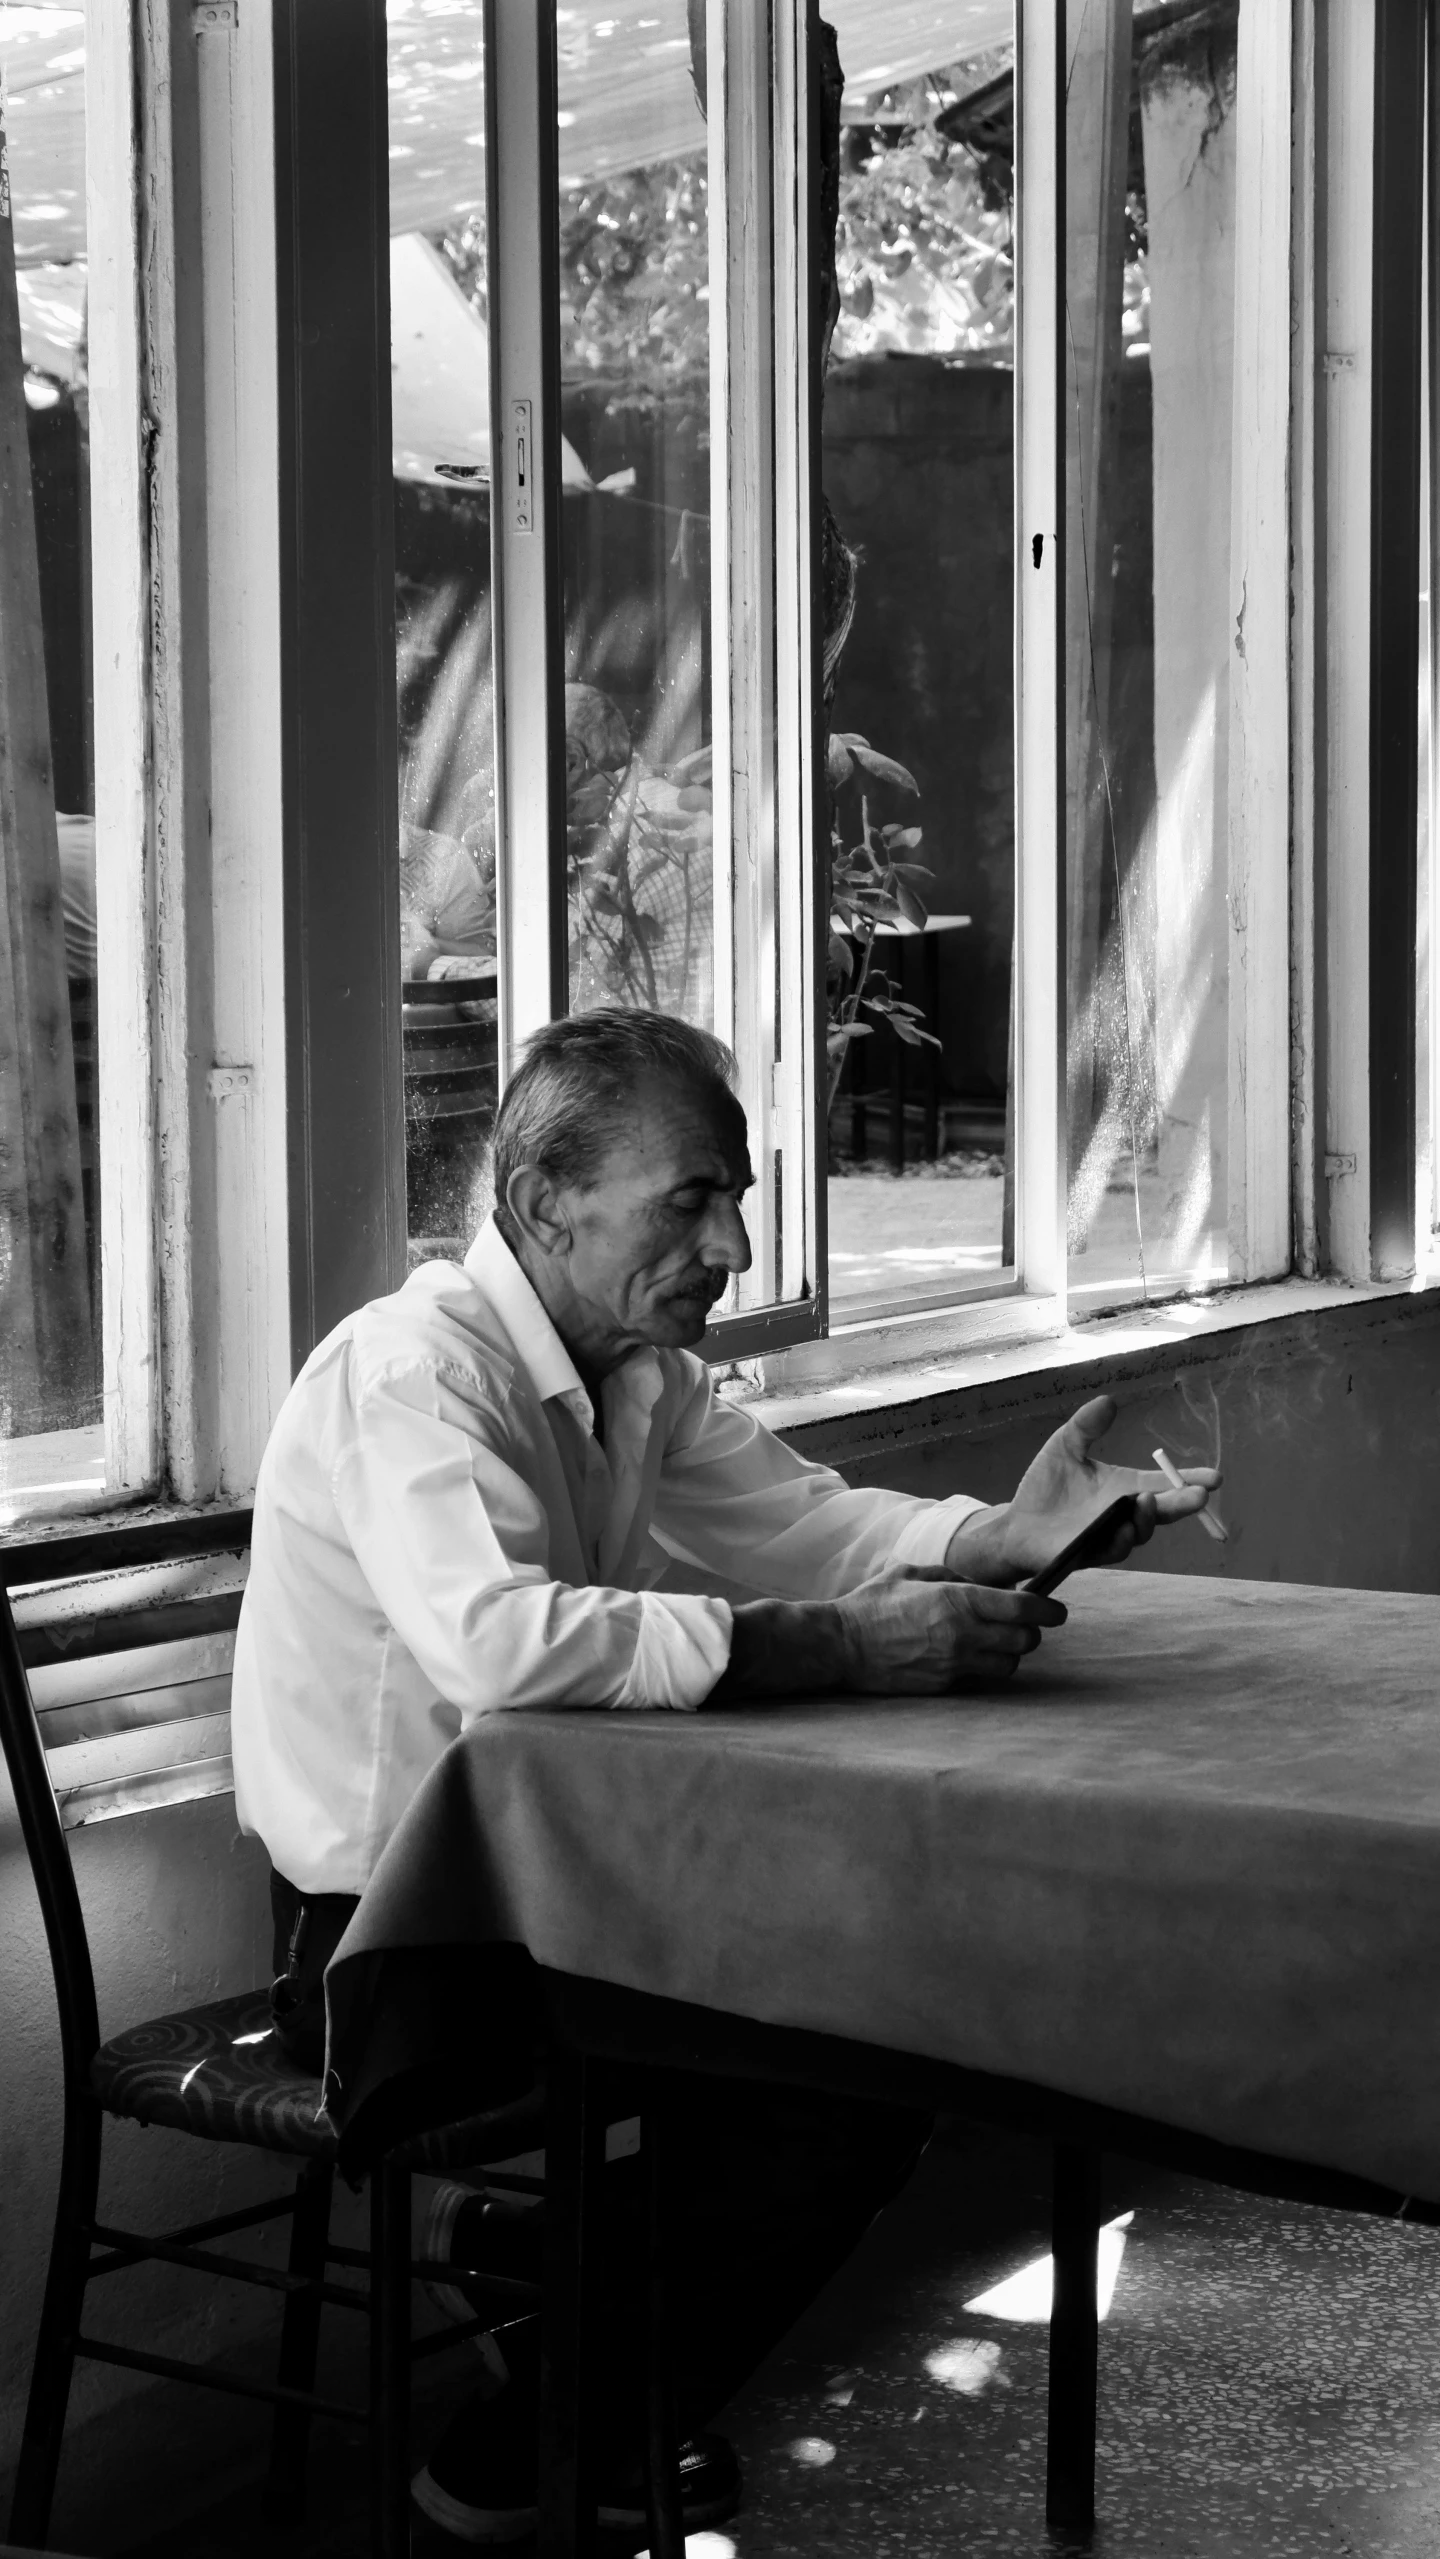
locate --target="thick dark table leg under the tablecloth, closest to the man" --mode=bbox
[537,2052,606,2559]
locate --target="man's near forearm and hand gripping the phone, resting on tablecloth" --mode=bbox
[706,1566,1064,1707]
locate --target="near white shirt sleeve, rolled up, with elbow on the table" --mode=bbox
[333,1364,732,1722]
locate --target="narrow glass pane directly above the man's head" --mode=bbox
[560,0,714,1026]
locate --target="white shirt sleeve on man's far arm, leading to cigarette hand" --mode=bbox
[655,1359,985,1599]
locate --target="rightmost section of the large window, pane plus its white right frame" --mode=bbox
[1064,5,1289,1310]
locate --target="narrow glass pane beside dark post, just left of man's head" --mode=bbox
[389,0,496,1262]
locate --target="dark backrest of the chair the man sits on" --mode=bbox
[0,1512,251,2096]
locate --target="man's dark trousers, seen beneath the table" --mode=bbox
[271,1876,931,2434]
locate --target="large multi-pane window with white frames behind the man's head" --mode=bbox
[391,0,1292,1356]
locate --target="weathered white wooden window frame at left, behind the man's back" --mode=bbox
[57,0,289,1515]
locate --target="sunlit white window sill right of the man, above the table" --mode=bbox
[724,1269,1440,1456]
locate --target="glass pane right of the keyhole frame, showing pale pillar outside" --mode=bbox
[1067,0,1238,1308]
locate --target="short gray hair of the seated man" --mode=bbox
[491,1006,739,1244]
